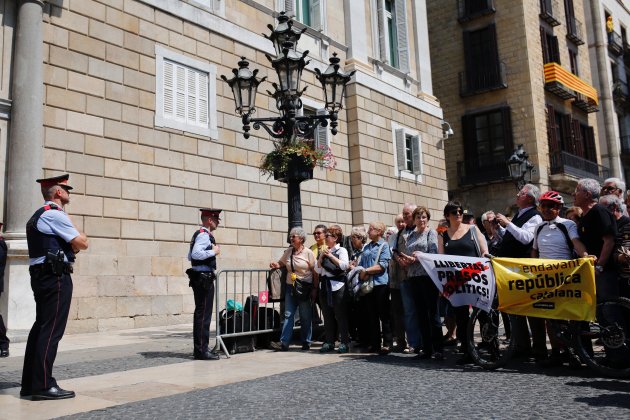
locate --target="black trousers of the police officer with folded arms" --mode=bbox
[22,267,72,393]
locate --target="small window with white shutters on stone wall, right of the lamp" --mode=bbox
[392,122,424,181]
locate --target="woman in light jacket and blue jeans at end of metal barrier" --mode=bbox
[269,227,318,351]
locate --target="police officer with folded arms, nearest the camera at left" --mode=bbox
[20,174,88,400]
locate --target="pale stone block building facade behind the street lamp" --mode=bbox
[0,0,447,337]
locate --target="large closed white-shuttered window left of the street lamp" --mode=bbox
[155,46,218,138]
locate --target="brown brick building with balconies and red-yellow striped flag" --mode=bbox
[427,0,607,216]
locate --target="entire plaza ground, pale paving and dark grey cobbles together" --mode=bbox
[0,325,630,420]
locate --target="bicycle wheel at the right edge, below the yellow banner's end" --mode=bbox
[573,298,630,378]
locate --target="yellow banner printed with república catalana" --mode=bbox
[492,258,596,321]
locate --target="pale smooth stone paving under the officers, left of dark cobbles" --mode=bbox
[0,325,341,420]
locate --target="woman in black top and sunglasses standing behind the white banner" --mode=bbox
[438,201,488,365]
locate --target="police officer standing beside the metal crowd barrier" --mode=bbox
[186,209,222,360]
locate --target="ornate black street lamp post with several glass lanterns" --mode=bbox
[221,12,354,238]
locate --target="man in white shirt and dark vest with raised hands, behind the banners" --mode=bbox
[496,184,547,360]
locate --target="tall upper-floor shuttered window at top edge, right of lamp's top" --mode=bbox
[376,0,409,73]
